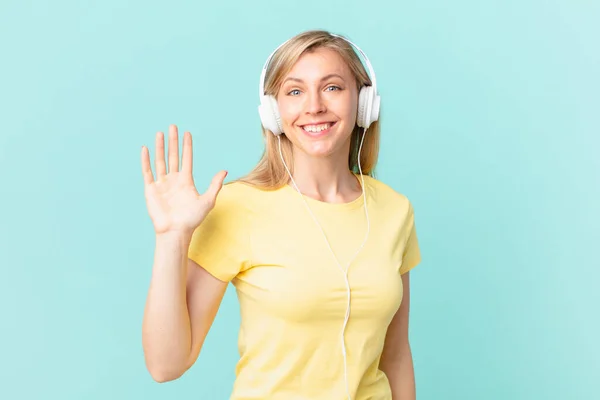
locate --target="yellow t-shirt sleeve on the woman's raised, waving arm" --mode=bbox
[188,185,251,282]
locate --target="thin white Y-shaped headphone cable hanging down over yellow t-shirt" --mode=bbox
[277,128,371,400]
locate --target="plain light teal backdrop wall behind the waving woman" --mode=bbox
[0,0,600,400]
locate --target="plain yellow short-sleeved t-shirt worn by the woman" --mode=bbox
[189,176,420,400]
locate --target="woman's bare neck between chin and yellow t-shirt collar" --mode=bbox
[290,151,362,203]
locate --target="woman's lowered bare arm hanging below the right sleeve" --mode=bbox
[379,272,416,400]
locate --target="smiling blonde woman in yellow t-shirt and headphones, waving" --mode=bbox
[142,31,420,400]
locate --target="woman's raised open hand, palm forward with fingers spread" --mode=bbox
[141,125,227,235]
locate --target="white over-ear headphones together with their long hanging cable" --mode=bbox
[258,34,380,400]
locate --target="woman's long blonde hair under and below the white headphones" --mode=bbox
[237,30,380,190]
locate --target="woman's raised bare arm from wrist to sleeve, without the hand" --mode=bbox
[142,235,227,382]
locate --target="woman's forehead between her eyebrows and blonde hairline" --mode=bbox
[286,47,352,80]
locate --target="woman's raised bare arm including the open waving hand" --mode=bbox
[141,125,232,382]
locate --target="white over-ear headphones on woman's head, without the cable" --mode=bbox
[258,33,381,136]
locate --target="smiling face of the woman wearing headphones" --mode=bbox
[277,48,358,156]
